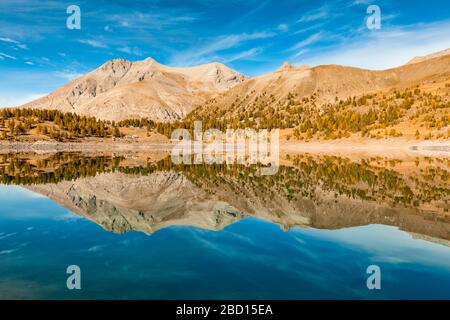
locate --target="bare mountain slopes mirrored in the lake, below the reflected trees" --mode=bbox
[27,166,450,241]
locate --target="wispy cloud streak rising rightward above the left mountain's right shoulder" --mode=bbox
[172,32,276,66]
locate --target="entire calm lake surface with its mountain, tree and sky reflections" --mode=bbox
[0,151,450,299]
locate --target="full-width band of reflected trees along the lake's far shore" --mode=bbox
[0,153,450,211]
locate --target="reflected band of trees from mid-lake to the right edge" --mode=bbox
[174,156,450,210]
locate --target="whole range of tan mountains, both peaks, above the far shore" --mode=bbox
[18,49,450,129]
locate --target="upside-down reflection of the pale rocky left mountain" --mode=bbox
[28,172,244,234]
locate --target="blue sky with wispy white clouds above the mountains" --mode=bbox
[0,0,450,106]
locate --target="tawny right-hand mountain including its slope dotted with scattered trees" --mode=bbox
[185,51,450,135]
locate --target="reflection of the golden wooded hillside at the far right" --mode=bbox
[294,156,450,210]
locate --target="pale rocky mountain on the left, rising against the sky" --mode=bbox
[18,58,246,121]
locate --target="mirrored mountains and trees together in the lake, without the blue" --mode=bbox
[0,153,450,240]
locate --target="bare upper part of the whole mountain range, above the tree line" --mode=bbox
[17,49,450,126]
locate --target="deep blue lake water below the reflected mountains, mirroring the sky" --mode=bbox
[0,186,450,299]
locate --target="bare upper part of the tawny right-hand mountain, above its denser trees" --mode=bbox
[188,51,450,128]
